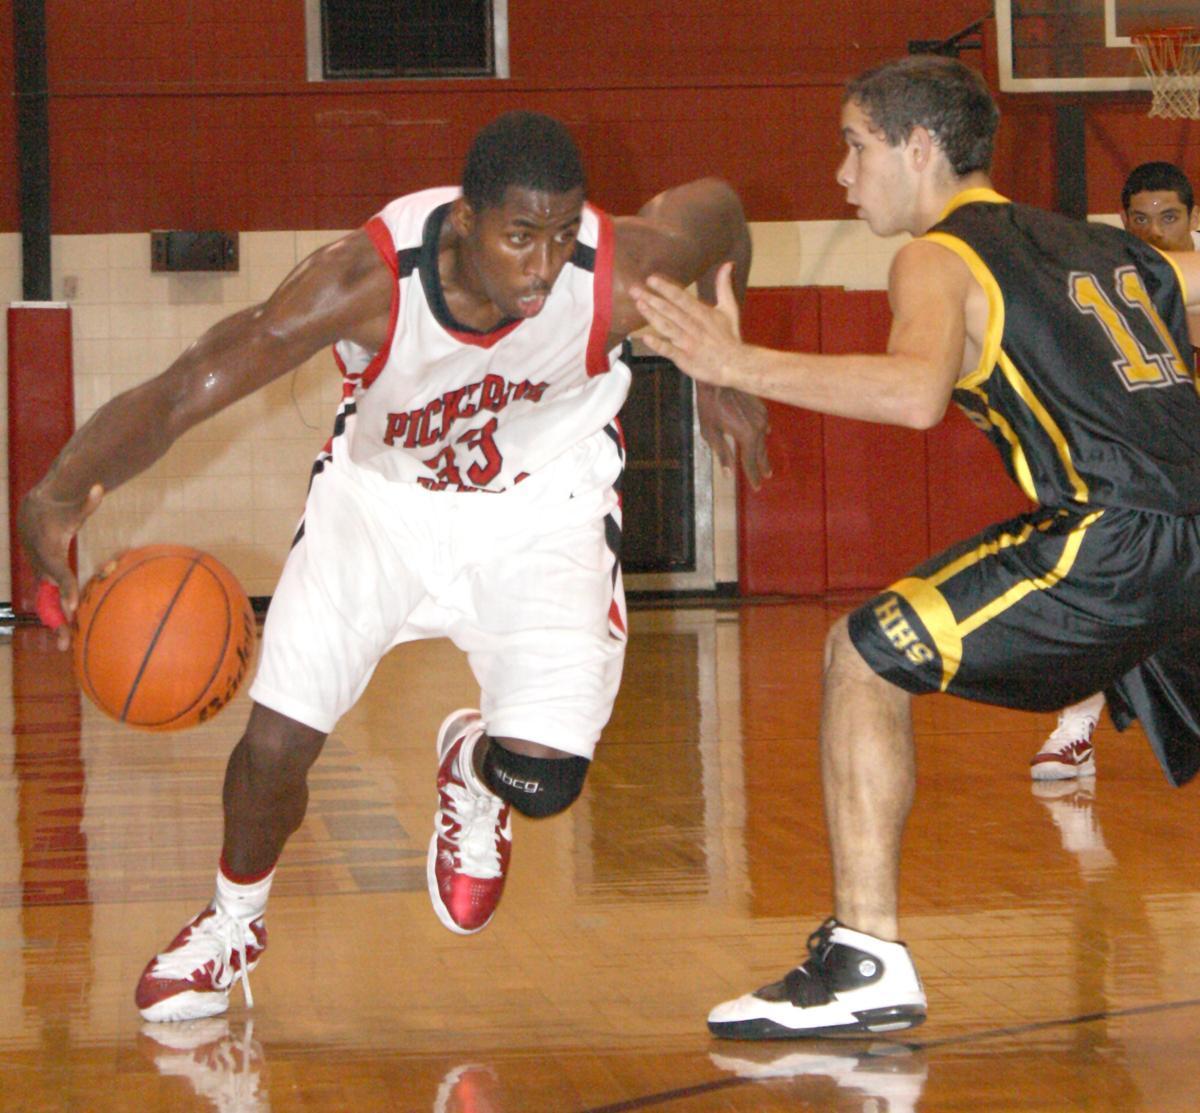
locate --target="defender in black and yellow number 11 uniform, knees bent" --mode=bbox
[635,56,1200,1039]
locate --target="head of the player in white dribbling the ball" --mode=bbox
[452,112,586,317]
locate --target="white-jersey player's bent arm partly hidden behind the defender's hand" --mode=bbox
[610,178,770,488]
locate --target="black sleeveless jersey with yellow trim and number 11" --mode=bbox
[926,189,1200,515]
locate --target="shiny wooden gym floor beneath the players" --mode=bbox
[0,603,1200,1113]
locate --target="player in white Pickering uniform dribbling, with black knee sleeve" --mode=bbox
[19,113,767,1021]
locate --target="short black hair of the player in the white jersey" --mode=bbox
[462,112,586,211]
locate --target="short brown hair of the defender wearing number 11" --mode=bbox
[842,54,1000,178]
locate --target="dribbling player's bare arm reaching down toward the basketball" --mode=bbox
[18,231,395,646]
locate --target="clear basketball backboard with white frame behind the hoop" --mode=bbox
[996,0,1200,92]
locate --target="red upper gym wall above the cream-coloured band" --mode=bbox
[0,0,1200,234]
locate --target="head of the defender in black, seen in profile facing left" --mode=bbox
[838,54,1000,235]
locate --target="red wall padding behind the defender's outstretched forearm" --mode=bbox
[738,287,1030,595]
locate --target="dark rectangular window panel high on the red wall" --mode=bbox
[320,0,496,78]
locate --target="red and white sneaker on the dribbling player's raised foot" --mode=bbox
[425,709,512,935]
